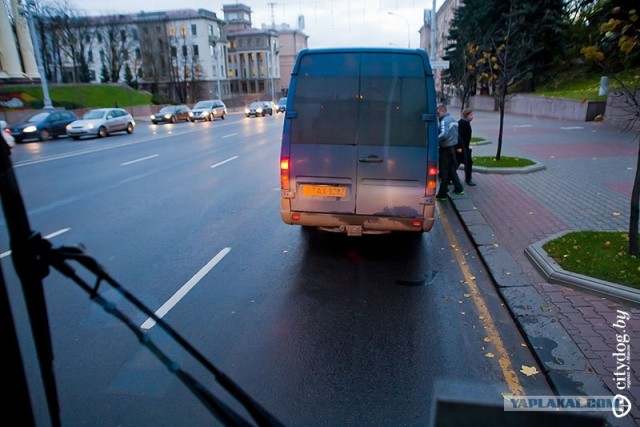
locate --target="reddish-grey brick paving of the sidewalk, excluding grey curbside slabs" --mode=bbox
[460,111,640,425]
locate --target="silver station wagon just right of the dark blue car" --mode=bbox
[67,108,136,139]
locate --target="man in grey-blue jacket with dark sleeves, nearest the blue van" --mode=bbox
[436,104,464,200]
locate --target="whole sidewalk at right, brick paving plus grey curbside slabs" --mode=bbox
[450,111,640,426]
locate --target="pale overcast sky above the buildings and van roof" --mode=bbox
[74,0,443,48]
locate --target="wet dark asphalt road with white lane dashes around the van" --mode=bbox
[0,115,551,426]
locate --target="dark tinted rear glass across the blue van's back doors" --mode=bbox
[291,53,427,146]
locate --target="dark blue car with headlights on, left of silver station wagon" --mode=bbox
[9,110,78,144]
